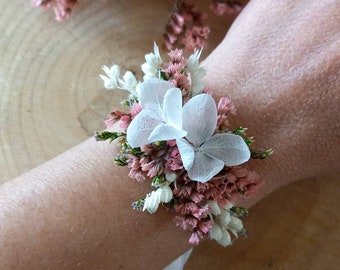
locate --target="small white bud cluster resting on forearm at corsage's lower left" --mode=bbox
[143,186,173,214]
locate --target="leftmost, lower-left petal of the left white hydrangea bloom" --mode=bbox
[126,110,162,147]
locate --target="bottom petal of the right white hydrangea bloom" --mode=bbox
[187,150,224,183]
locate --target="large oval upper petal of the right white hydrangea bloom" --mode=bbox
[182,94,217,146]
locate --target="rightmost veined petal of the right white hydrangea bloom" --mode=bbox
[201,133,250,166]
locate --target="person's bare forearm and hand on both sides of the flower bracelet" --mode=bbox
[0,0,340,269]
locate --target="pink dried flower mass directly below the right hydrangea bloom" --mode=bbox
[173,166,263,244]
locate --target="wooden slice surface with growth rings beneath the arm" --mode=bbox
[0,0,340,270]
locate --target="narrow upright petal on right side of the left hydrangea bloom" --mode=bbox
[163,88,182,129]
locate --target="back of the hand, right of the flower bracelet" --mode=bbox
[204,0,340,208]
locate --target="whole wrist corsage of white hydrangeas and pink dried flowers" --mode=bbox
[96,44,271,246]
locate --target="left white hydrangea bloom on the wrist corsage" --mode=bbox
[127,78,187,147]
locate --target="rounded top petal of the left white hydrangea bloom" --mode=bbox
[138,78,174,109]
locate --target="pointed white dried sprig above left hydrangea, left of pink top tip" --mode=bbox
[141,43,163,81]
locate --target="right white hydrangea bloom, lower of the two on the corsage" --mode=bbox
[176,94,250,183]
